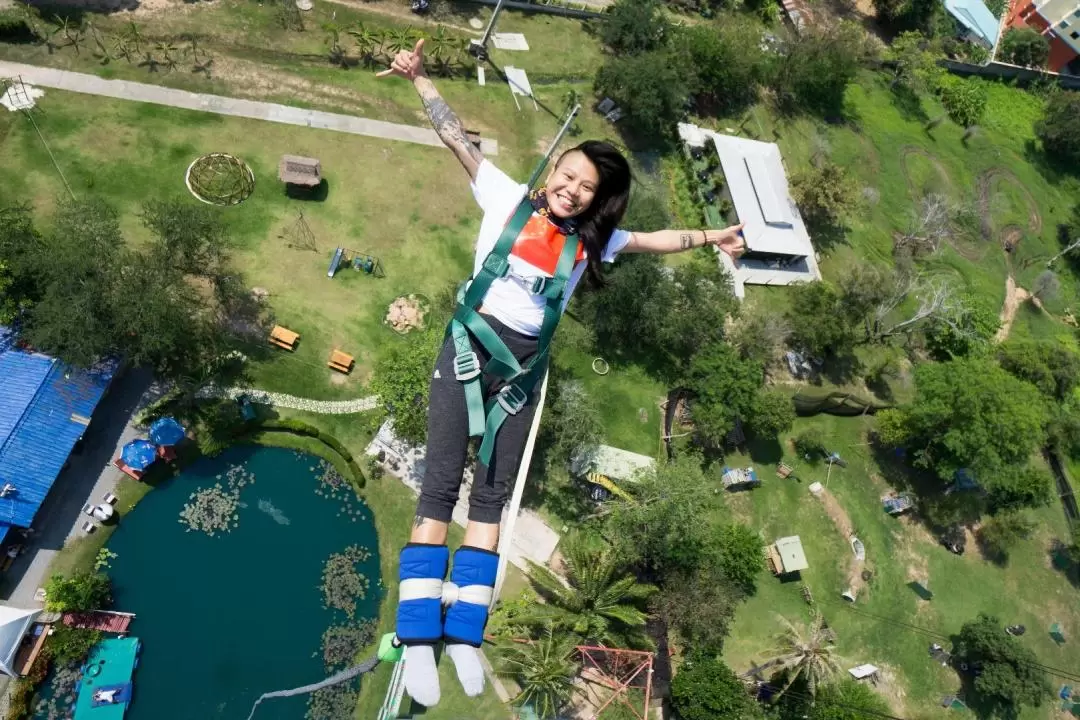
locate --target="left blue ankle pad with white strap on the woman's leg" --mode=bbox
[396,543,450,644]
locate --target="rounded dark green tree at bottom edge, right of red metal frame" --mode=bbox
[672,655,761,720]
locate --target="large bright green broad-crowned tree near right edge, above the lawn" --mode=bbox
[878,357,1049,483]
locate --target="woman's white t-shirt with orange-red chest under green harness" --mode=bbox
[471,160,631,336]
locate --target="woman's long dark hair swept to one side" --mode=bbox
[555,140,632,286]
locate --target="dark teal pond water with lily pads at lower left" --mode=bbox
[101,446,381,720]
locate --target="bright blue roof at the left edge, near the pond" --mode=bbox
[0,327,118,540]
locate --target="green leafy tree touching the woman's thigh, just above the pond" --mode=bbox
[372,331,436,445]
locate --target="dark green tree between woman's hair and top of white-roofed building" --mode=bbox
[595,50,690,142]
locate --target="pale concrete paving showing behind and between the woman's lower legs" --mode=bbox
[367,421,558,572]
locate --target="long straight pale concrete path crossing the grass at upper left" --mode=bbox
[0,60,498,155]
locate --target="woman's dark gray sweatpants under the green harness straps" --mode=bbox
[416,315,537,522]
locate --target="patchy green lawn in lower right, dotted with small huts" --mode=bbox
[725,416,1080,719]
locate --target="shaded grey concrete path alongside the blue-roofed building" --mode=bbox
[0,370,151,608]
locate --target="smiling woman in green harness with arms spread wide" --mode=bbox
[378,40,743,706]
